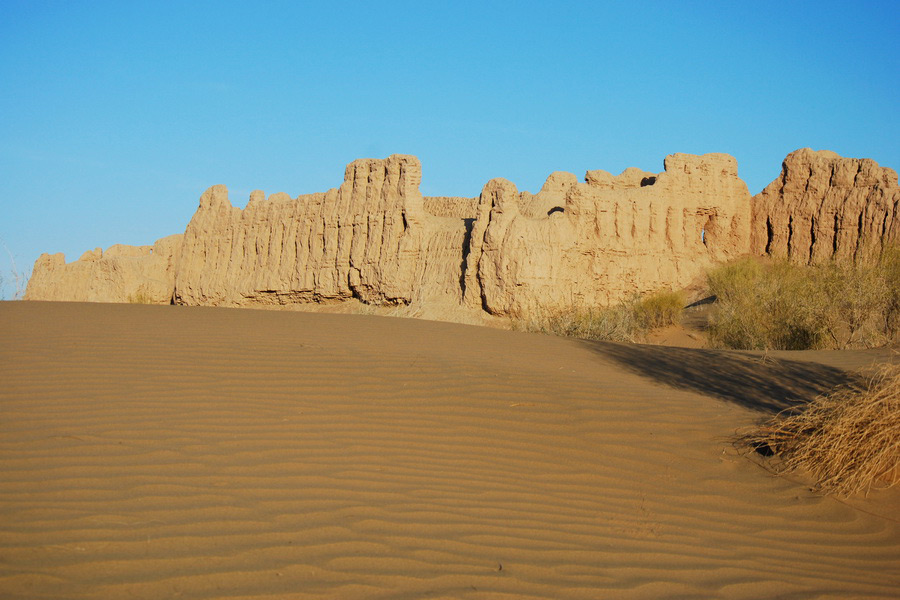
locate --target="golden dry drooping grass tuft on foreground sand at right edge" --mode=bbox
[743,365,900,496]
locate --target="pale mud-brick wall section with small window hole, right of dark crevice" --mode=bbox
[465,154,750,315]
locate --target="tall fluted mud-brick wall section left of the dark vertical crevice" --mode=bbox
[175,155,474,306]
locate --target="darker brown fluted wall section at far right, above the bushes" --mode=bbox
[751,148,900,264]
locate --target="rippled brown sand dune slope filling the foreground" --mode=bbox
[0,302,900,599]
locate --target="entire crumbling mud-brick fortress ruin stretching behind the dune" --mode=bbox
[25,149,900,316]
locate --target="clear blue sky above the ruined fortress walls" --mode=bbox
[0,0,900,297]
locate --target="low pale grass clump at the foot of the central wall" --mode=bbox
[512,291,684,342]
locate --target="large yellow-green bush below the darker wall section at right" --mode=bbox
[708,250,900,350]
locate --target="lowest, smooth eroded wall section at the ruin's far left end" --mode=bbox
[25,234,182,304]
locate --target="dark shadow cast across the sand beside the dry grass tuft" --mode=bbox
[582,340,860,413]
